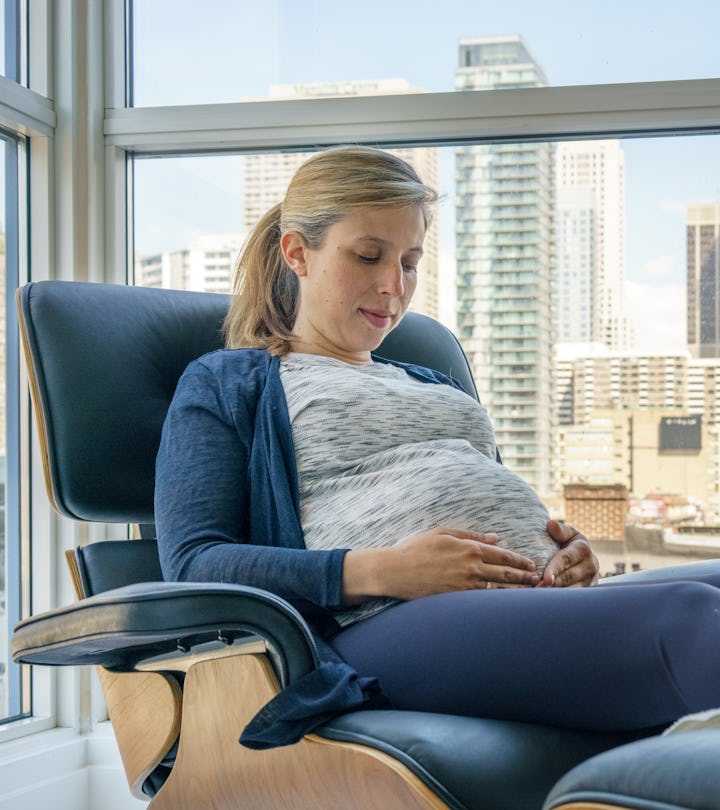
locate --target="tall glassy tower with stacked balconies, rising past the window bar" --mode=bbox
[455,36,555,494]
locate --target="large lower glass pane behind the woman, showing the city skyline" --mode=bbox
[134,131,720,574]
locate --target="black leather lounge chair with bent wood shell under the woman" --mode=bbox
[12,282,704,810]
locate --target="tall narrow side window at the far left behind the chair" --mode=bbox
[0,0,55,740]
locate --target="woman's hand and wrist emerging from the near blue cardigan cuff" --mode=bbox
[343,527,540,604]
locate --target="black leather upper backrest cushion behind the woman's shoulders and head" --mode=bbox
[18,281,475,523]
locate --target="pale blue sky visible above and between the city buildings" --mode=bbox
[134,0,720,351]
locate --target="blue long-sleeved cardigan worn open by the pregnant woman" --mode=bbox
[155,349,460,748]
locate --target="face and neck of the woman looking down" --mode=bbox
[282,205,425,363]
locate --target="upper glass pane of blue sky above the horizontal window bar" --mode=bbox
[132,0,720,106]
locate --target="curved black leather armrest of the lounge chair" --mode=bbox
[12,582,318,686]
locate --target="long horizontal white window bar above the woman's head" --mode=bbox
[104,79,720,155]
